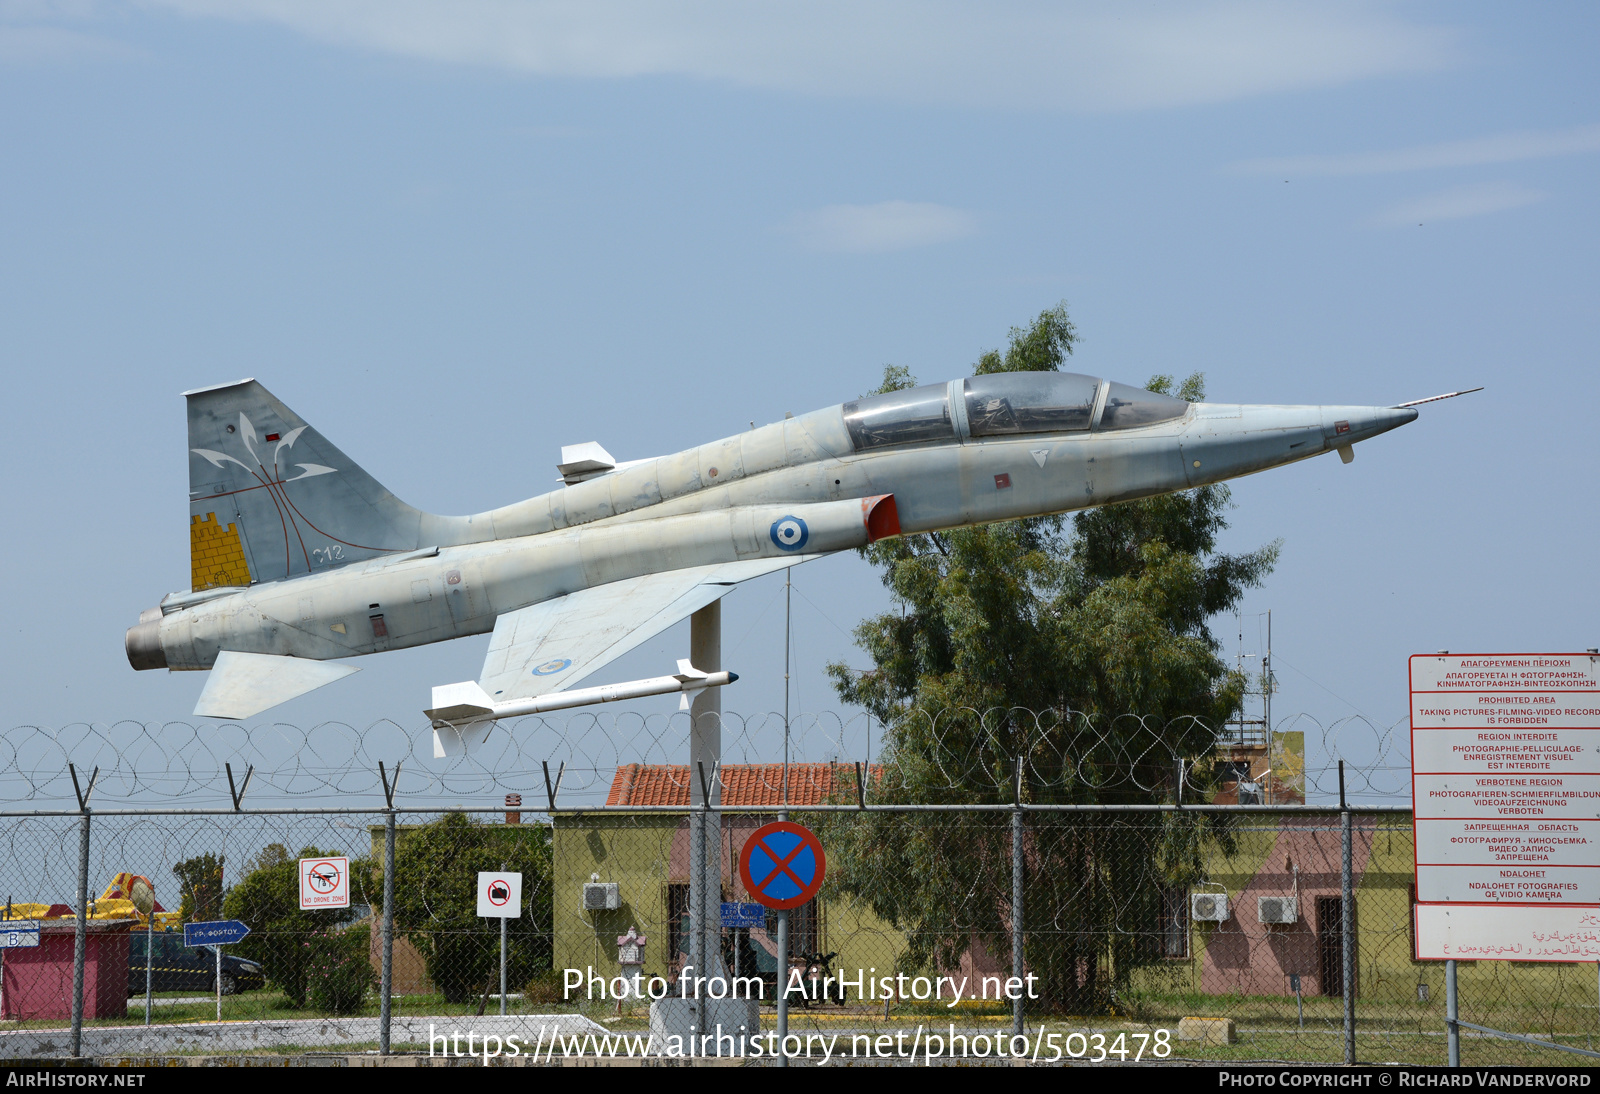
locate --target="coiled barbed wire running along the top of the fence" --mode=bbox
[0,709,1410,808]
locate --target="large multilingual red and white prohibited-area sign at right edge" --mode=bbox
[1411,653,1600,961]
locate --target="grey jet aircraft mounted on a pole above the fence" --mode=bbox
[126,373,1448,755]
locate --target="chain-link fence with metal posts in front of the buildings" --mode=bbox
[0,712,1600,1065]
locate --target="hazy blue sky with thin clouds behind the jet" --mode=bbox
[0,0,1600,800]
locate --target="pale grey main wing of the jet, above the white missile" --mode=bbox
[478,555,821,702]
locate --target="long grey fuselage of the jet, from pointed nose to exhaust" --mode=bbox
[128,381,1416,669]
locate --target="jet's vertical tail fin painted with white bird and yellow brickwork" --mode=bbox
[184,379,424,590]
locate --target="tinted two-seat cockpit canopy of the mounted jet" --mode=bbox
[843,373,1189,451]
